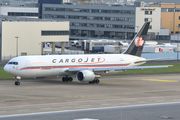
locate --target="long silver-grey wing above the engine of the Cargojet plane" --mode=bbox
[66,65,173,73]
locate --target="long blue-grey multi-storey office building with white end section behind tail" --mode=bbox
[42,2,163,40]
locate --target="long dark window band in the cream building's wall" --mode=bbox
[41,31,69,36]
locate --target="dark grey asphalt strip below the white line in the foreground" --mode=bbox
[0,103,180,120]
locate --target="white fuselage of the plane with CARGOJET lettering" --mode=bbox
[4,54,145,77]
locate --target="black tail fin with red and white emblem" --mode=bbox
[123,22,150,57]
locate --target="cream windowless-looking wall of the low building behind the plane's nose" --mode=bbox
[2,21,69,58]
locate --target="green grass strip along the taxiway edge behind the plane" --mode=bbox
[0,63,180,79]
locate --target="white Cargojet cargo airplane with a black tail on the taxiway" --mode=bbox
[4,22,172,85]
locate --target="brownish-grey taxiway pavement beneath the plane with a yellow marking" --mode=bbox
[0,73,180,116]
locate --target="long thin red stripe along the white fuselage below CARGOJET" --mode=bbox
[21,63,131,70]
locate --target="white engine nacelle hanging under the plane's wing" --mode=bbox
[76,70,96,82]
